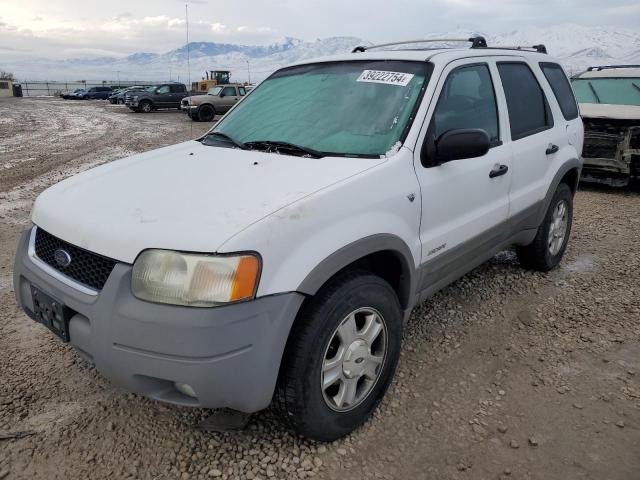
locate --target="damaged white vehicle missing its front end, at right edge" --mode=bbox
[571,65,640,187]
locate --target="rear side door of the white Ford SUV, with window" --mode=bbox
[497,57,565,231]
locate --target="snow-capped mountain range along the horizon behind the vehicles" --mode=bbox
[3,24,640,83]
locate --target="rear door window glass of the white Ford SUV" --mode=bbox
[498,62,553,140]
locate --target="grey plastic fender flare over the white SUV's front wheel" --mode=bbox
[297,233,417,310]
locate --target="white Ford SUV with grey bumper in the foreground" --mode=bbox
[14,38,583,440]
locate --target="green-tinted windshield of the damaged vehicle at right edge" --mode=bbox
[571,78,640,106]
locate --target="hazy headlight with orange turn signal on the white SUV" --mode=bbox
[131,250,260,307]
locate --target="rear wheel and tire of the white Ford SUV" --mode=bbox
[516,183,573,272]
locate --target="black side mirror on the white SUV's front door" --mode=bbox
[434,128,490,165]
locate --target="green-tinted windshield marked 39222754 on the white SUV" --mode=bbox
[212,61,432,156]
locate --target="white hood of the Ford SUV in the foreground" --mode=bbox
[32,141,384,263]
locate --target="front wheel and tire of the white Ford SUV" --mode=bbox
[275,271,402,442]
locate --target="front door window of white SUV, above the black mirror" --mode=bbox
[433,65,500,145]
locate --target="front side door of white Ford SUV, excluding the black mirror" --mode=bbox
[415,58,511,293]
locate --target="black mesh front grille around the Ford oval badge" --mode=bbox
[35,228,116,290]
